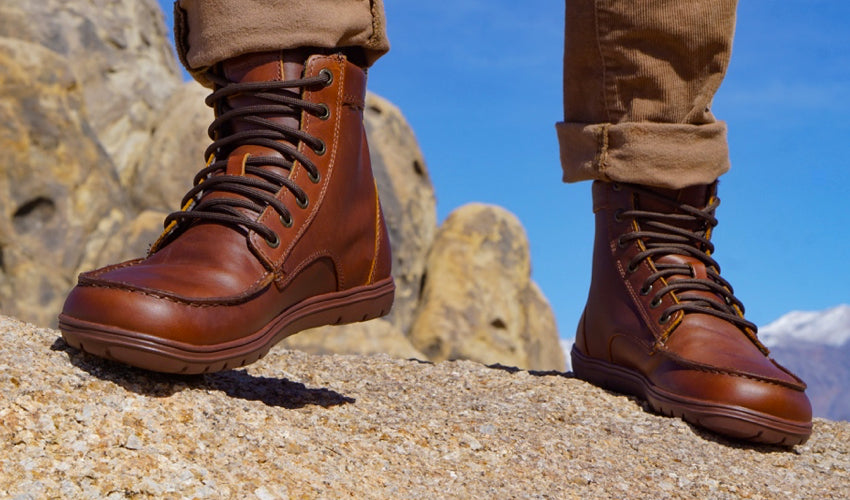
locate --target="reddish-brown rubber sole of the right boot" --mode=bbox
[570,346,812,446]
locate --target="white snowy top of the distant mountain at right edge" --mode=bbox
[759,304,850,347]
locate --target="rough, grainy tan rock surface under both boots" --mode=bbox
[0,318,850,499]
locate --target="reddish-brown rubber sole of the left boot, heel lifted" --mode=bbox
[59,278,395,374]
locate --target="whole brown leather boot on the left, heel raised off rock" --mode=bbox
[59,51,395,373]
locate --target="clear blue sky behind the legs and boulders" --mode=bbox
[159,0,850,338]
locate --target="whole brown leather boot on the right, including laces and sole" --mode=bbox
[572,182,812,445]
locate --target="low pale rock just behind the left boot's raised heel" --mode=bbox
[281,318,426,360]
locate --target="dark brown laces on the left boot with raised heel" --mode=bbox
[165,70,333,246]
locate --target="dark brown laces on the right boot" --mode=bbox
[615,186,760,345]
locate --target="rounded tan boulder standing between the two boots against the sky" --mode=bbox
[409,204,565,370]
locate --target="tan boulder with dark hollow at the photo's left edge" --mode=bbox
[0,38,127,325]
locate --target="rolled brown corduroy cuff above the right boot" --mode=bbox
[555,122,729,189]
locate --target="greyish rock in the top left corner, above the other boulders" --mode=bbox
[0,0,180,176]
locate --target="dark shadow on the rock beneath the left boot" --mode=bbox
[50,337,356,409]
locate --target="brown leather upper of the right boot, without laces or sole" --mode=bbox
[576,182,811,421]
